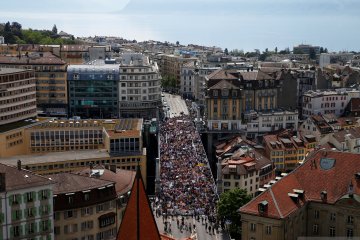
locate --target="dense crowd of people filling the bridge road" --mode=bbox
[157,115,217,219]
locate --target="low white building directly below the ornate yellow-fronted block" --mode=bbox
[243,110,299,138]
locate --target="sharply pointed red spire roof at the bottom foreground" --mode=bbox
[117,166,160,240]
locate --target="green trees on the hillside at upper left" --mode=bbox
[0,22,75,45]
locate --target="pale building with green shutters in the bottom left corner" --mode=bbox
[0,162,54,240]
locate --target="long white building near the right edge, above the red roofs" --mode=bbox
[302,89,360,118]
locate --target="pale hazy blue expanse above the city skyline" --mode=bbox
[0,0,360,51]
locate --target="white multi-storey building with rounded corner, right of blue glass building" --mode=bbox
[119,53,161,118]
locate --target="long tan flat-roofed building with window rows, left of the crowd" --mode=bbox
[0,119,146,186]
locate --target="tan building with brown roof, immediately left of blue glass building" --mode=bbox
[0,52,68,116]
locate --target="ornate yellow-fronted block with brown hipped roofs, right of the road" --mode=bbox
[206,69,281,130]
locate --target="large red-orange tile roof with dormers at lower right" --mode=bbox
[240,150,360,219]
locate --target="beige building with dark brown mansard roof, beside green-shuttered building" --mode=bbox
[51,173,117,240]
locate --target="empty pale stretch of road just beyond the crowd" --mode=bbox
[163,93,189,118]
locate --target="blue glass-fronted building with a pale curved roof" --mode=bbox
[67,60,119,119]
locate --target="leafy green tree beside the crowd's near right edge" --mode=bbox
[217,188,251,239]
